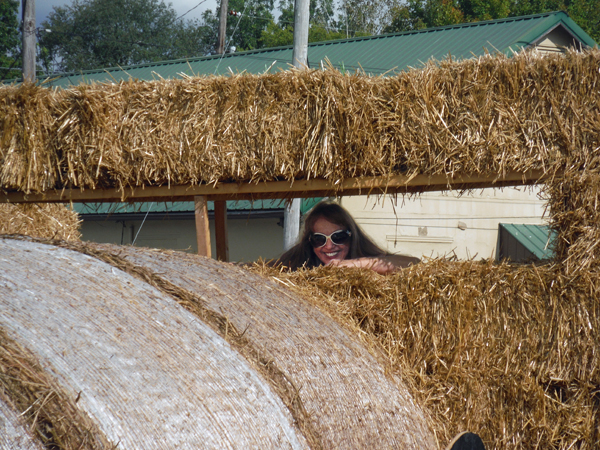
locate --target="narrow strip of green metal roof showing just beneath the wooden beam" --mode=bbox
[73,198,321,216]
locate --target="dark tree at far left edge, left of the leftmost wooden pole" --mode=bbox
[0,0,21,79]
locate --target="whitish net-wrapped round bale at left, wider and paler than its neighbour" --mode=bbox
[0,239,308,449]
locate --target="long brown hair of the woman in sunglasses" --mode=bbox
[275,201,387,270]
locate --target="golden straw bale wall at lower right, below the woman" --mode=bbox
[256,260,600,450]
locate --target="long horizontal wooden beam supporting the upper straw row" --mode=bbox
[0,170,544,203]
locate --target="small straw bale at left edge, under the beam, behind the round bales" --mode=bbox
[0,203,81,241]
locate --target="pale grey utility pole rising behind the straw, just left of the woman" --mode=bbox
[283,0,310,250]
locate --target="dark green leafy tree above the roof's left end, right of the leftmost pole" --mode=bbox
[40,0,209,71]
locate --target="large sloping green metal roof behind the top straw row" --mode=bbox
[42,11,597,87]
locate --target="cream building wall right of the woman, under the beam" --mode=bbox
[341,187,547,260]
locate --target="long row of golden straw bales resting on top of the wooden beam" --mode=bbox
[0,50,600,192]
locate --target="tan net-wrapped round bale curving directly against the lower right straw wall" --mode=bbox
[88,245,436,449]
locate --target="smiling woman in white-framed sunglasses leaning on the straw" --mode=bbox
[277,202,420,274]
